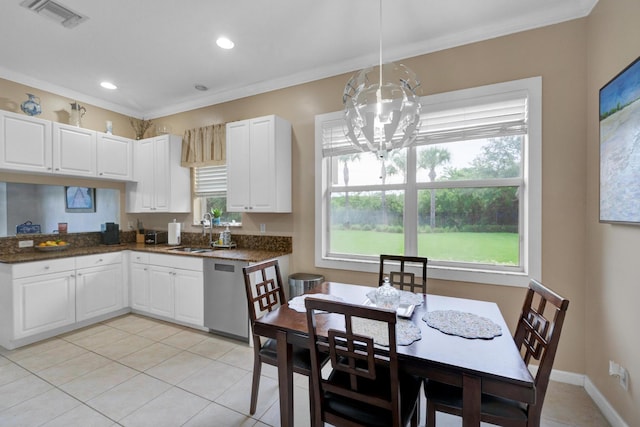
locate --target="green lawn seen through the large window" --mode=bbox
[331,229,519,265]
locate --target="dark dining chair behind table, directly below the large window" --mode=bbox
[378,255,429,294]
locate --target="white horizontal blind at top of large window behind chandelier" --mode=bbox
[321,91,528,157]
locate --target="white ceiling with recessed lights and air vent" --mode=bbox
[0,0,597,118]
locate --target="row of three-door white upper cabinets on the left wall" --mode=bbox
[0,111,133,181]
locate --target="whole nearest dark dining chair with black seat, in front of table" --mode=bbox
[305,297,421,427]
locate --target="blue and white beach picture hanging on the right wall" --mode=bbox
[599,57,640,225]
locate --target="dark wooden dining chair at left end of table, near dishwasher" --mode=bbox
[242,260,320,415]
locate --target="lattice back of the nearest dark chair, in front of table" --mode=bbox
[305,297,400,426]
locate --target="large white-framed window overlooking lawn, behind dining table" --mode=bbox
[316,78,541,286]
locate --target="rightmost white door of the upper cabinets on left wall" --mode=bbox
[97,133,133,181]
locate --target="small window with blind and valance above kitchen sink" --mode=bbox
[193,165,242,225]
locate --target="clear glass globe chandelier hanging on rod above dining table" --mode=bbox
[342,0,420,159]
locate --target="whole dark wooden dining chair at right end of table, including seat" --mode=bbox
[425,280,569,427]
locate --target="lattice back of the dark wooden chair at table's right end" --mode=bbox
[513,280,569,425]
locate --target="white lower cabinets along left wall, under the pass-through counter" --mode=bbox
[0,252,129,349]
